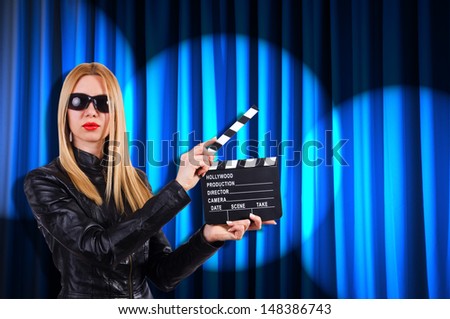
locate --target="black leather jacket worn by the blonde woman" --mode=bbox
[24,150,222,298]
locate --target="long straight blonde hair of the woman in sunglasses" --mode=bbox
[58,62,151,212]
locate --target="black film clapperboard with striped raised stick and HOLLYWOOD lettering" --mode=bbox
[201,106,282,224]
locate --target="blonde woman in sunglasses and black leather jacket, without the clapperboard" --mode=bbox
[25,63,270,298]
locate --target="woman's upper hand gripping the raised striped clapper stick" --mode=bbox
[176,137,216,191]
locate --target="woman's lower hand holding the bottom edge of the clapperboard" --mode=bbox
[203,214,277,243]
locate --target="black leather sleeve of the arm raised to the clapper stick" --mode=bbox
[24,169,190,265]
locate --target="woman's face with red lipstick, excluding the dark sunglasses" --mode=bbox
[67,75,109,155]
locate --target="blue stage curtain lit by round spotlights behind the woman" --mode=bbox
[0,0,450,298]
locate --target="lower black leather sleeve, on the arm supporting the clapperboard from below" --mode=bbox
[147,226,224,292]
